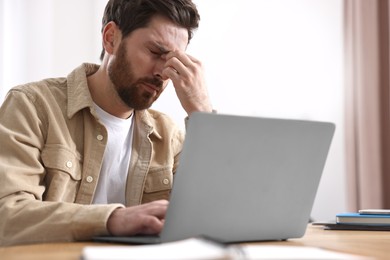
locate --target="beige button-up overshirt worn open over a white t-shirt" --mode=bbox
[0,64,184,245]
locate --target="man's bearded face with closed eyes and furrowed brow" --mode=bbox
[108,16,188,110]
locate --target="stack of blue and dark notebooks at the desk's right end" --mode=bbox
[314,209,390,231]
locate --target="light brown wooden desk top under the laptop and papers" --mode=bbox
[0,224,390,260]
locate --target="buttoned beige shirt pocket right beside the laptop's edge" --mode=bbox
[142,167,173,203]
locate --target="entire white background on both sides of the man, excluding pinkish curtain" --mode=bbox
[0,0,345,220]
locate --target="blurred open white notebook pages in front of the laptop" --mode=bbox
[82,238,367,260]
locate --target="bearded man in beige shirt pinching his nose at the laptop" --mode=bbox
[0,0,212,245]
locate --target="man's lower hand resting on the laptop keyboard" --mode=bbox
[107,200,169,236]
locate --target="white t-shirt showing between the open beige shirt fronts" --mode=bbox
[93,104,133,205]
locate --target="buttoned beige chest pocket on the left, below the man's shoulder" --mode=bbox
[41,145,82,202]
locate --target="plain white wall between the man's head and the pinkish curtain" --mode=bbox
[158,0,346,220]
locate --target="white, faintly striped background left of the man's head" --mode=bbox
[0,0,106,98]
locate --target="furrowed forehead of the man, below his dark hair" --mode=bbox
[125,15,188,51]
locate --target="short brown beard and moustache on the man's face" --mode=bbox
[108,42,163,110]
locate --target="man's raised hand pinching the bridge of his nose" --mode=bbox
[163,51,212,115]
